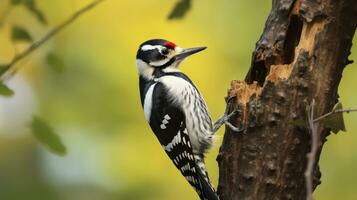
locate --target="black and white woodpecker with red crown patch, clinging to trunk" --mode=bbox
[136,39,241,200]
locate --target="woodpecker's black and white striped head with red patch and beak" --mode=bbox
[136,39,206,79]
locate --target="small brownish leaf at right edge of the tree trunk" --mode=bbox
[321,102,346,134]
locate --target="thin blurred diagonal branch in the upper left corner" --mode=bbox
[0,0,105,82]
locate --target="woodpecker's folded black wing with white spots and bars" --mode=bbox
[145,83,218,200]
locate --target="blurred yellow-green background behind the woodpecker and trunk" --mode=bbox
[0,0,357,200]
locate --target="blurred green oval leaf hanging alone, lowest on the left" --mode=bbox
[31,116,67,156]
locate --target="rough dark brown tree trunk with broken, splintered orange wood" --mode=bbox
[217,0,357,200]
